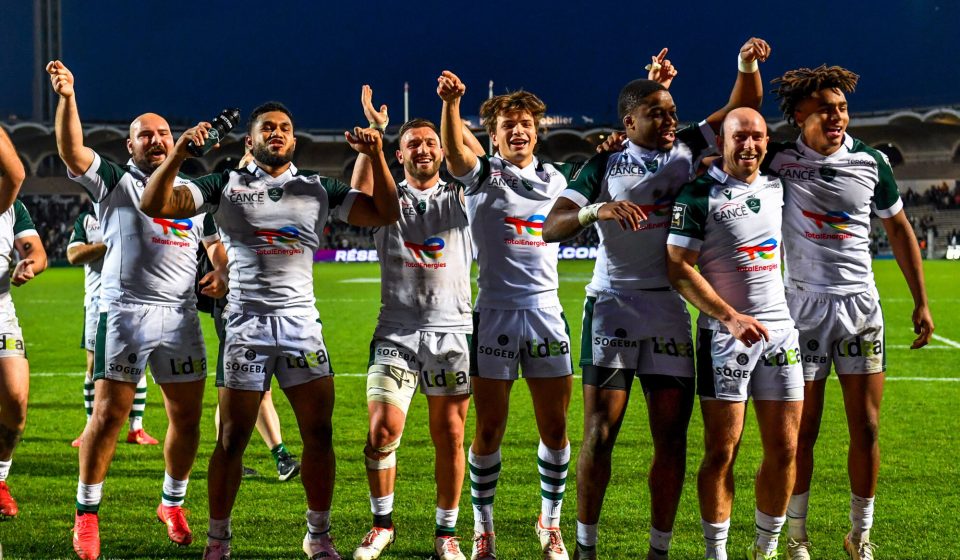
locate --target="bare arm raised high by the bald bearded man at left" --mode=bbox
[47,60,94,175]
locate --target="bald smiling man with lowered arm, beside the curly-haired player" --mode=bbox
[667,108,803,560]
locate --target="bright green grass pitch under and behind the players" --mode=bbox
[0,261,960,559]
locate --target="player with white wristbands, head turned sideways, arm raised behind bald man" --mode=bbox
[543,38,770,559]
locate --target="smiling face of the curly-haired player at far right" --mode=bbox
[794,88,850,156]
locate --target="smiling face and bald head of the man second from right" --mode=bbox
[719,108,770,183]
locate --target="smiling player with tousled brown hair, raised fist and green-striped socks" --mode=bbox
[437,71,577,560]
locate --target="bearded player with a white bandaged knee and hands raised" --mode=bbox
[351,85,482,560]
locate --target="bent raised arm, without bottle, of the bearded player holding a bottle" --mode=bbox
[343,127,400,226]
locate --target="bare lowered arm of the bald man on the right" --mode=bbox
[667,245,770,348]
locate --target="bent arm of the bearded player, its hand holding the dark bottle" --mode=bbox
[140,122,211,219]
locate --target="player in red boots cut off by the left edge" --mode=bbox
[0,124,47,519]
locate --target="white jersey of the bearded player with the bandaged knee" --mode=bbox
[373,181,473,333]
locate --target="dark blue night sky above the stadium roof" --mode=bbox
[0,0,960,128]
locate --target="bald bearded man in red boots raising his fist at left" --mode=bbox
[47,61,226,559]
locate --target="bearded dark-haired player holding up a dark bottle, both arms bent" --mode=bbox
[141,102,400,559]
